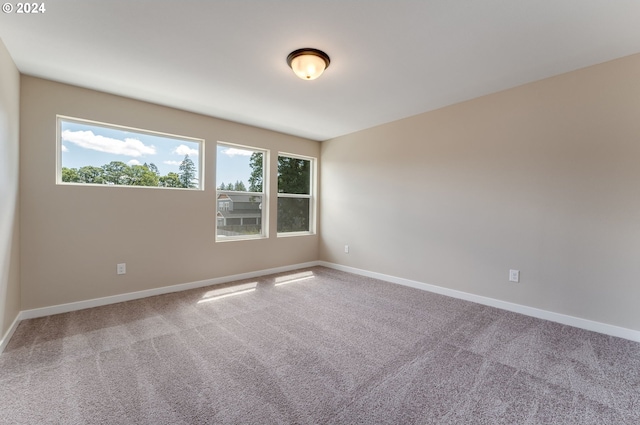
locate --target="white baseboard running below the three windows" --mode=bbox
[16,261,319,322]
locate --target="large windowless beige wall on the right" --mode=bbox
[320,55,640,330]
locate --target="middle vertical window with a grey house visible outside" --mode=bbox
[216,143,268,241]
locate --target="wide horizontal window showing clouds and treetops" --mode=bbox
[57,116,204,189]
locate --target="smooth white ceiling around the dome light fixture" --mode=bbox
[0,0,640,140]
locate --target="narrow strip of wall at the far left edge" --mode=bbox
[0,40,20,340]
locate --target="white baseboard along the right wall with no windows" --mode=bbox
[319,261,640,342]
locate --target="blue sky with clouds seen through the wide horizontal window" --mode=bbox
[60,120,200,176]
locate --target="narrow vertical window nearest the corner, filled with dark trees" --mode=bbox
[278,154,315,235]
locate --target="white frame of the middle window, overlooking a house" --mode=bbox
[215,141,270,242]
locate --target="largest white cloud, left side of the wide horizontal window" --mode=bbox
[62,130,156,157]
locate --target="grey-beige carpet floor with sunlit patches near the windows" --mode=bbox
[0,267,640,424]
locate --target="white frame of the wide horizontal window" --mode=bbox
[56,115,205,191]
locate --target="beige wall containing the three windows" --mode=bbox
[20,76,320,310]
